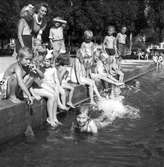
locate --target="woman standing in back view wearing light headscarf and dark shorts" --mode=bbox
[16,4,34,53]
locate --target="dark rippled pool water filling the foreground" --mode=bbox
[0,67,164,167]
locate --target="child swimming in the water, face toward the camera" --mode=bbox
[73,104,111,134]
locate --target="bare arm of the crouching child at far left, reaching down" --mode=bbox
[15,66,33,103]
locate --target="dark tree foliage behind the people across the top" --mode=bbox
[0,0,164,45]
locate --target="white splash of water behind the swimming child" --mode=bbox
[98,98,140,122]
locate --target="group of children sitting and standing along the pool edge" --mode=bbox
[1,17,126,131]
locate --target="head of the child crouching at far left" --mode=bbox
[17,47,33,66]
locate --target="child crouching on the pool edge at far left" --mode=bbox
[1,48,33,103]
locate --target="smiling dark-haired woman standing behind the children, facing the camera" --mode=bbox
[33,3,48,42]
